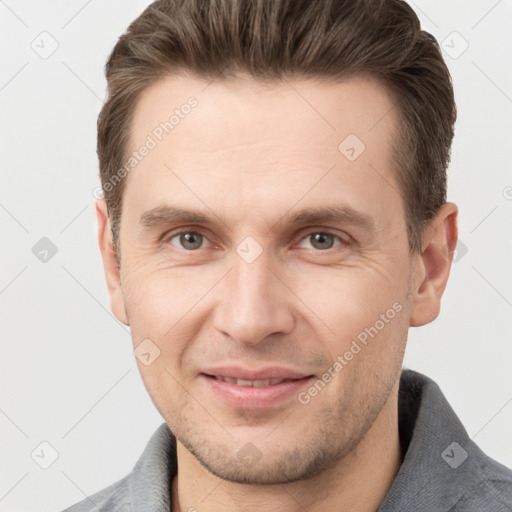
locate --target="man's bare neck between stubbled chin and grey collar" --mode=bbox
[171,390,401,512]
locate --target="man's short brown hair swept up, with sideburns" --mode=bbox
[97,0,456,252]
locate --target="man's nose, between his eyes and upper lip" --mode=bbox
[214,252,295,345]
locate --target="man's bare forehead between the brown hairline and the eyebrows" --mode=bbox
[123,71,401,231]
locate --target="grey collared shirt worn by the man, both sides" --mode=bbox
[64,370,512,512]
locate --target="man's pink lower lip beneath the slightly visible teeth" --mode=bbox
[200,374,313,410]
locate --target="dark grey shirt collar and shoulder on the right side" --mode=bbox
[379,370,512,512]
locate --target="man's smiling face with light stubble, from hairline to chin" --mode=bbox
[110,77,411,483]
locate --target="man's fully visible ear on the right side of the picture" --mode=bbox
[410,203,458,327]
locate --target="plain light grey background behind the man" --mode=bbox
[0,0,512,512]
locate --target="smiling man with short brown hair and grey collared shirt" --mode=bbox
[64,0,512,512]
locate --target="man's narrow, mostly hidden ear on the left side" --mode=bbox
[96,198,129,325]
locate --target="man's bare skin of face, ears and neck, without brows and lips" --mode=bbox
[97,76,457,512]
